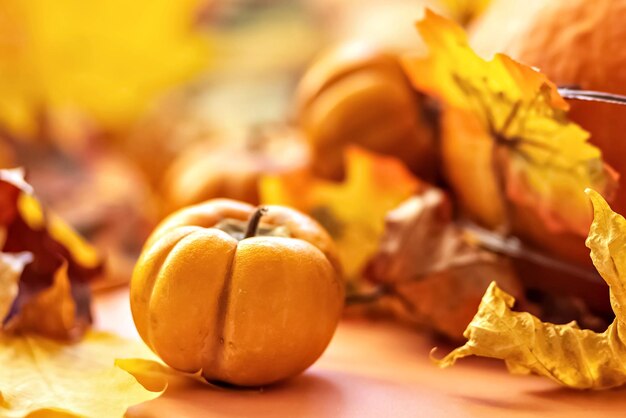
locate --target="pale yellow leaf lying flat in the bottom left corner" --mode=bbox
[0,332,167,418]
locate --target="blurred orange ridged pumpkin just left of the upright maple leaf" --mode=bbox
[296,43,435,179]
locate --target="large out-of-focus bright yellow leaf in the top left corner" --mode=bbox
[0,0,207,134]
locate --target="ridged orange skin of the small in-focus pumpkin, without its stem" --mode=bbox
[130,199,344,386]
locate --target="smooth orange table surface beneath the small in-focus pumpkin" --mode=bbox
[95,289,626,418]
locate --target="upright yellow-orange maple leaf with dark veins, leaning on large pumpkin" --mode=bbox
[404,11,616,236]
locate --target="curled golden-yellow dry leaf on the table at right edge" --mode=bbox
[436,190,626,389]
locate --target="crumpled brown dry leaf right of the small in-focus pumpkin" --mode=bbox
[367,188,522,340]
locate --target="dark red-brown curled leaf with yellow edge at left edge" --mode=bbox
[0,169,102,338]
